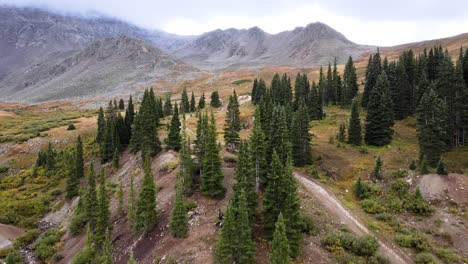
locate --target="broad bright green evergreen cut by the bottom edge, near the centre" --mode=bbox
[216,191,255,263]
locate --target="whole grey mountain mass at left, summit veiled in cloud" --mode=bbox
[0,6,199,102]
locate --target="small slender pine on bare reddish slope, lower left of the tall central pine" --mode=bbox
[170,176,188,238]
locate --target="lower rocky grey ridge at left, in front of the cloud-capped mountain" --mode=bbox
[0,36,200,102]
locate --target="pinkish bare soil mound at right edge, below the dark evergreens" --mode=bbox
[419,173,468,207]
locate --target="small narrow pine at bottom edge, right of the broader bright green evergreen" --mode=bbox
[269,213,291,264]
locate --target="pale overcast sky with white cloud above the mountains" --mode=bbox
[0,0,468,46]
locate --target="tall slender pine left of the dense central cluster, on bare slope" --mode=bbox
[200,112,226,199]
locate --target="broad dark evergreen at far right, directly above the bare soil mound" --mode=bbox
[416,85,449,166]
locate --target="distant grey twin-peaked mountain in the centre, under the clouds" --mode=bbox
[173,22,374,70]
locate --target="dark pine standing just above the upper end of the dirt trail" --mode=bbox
[291,101,312,167]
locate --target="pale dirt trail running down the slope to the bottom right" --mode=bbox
[294,172,413,264]
